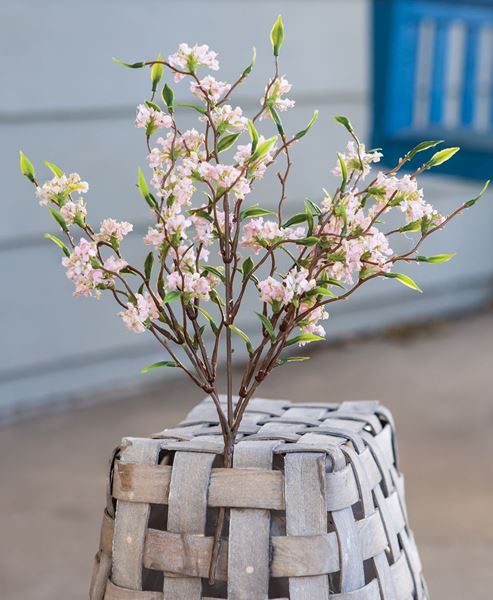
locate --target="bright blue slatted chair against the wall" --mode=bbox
[372,0,493,179]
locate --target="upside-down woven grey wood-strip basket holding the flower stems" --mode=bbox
[90,399,428,600]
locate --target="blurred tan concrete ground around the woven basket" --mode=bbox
[0,313,493,600]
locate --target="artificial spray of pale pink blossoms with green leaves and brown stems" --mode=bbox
[21,18,486,466]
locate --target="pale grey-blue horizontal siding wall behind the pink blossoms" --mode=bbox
[0,0,493,416]
